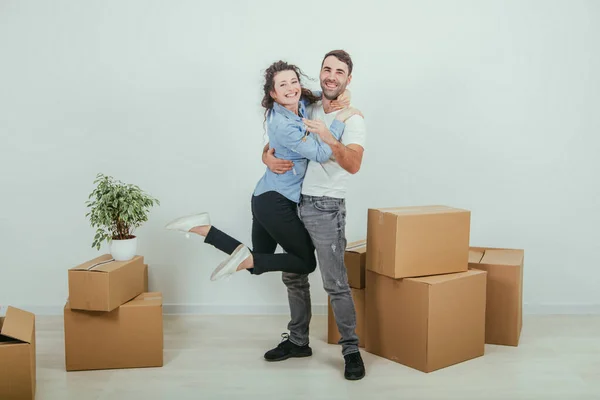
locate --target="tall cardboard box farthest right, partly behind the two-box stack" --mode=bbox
[469,247,525,346]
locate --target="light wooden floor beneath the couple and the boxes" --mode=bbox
[36,315,600,400]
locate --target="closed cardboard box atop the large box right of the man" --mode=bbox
[367,206,471,278]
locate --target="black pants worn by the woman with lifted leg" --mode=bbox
[204,192,317,275]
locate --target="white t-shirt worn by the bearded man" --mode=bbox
[302,101,367,199]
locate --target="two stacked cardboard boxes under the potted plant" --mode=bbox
[64,254,163,371]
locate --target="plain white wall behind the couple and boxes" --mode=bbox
[0,0,600,313]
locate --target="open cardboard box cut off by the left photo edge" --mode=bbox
[0,306,36,400]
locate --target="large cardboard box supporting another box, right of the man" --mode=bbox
[365,270,487,372]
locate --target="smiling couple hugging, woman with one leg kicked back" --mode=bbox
[167,50,366,380]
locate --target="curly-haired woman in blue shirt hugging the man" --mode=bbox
[167,61,360,280]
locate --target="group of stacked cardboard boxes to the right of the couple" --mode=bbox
[329,206,523,372]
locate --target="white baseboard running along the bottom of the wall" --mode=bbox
[7,304,600,315]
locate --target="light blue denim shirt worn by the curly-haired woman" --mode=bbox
[254,93,345,203]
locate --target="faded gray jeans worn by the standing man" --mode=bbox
[283,196,359,355]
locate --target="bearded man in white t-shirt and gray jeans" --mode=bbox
[263,50,366,380]
